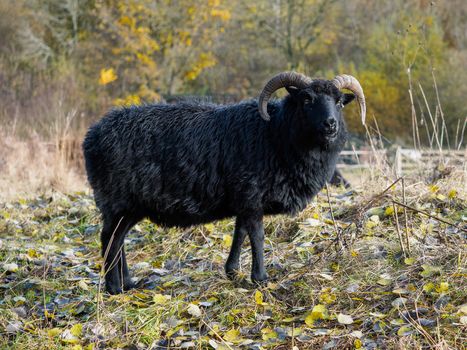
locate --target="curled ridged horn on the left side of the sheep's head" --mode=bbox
[258,72,313,121]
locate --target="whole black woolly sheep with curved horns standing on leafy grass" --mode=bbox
[83,72,365,294]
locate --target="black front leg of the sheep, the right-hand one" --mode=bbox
[246,215,268,282]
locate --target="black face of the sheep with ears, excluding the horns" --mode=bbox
[287,82,355,145]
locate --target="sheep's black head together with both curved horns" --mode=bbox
[259,72,366,143]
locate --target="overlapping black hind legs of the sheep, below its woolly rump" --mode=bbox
[101,217,133,294]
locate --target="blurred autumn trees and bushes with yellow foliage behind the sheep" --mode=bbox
[0,0,467,142]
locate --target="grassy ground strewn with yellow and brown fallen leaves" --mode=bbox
[0,174,467,349]
